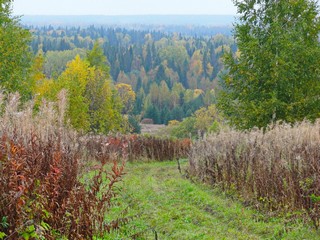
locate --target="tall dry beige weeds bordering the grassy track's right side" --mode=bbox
[190,122,320,227]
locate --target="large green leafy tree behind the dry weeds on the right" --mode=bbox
[218,0,320,129]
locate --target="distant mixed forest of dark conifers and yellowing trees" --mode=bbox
[31,26,236,124]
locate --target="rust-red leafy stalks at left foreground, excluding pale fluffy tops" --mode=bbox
[0,131,124,239]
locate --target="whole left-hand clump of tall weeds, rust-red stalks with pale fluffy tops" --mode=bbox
[0,92,126,239]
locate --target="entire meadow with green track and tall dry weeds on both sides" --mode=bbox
[0,92,320,239]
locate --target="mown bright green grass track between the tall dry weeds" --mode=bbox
[104,161,320,240]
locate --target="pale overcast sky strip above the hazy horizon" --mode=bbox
[13,0,236,15]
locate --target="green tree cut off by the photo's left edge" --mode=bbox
[0,0,32,98]
